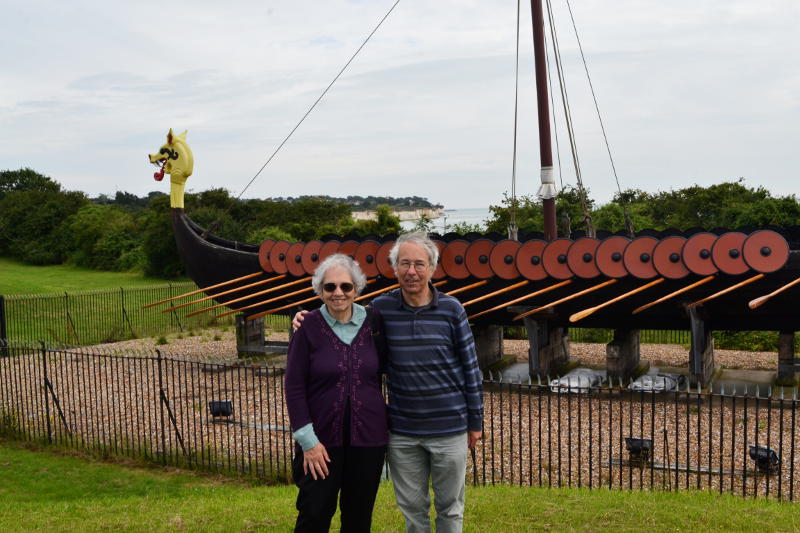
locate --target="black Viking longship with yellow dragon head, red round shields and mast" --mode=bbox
[145,0,800,384]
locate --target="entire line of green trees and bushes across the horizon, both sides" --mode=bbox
[0,168,800,278]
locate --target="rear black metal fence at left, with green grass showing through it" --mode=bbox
[0,282,288,346]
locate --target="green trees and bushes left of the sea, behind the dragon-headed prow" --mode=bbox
[0,168,401,278]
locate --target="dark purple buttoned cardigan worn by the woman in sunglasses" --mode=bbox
[285,309,388,448]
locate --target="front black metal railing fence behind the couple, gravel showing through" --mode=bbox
[0,343,800,501]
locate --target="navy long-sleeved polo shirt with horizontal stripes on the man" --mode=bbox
[372,285,483,437]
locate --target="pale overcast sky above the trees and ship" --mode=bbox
[0,0,800,209]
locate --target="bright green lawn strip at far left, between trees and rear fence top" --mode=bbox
[0,258,185,295]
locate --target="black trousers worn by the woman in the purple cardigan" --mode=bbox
[292,446,386,533]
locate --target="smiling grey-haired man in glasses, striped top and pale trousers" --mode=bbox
[295,233,483,533]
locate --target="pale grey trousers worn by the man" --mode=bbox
[388,432,467,533]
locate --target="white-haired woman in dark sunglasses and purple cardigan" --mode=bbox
[286,254,388,532]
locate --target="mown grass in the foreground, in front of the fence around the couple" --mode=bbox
[0,441,800,533]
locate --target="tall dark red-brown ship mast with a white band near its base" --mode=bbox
[531,0,558,241]
